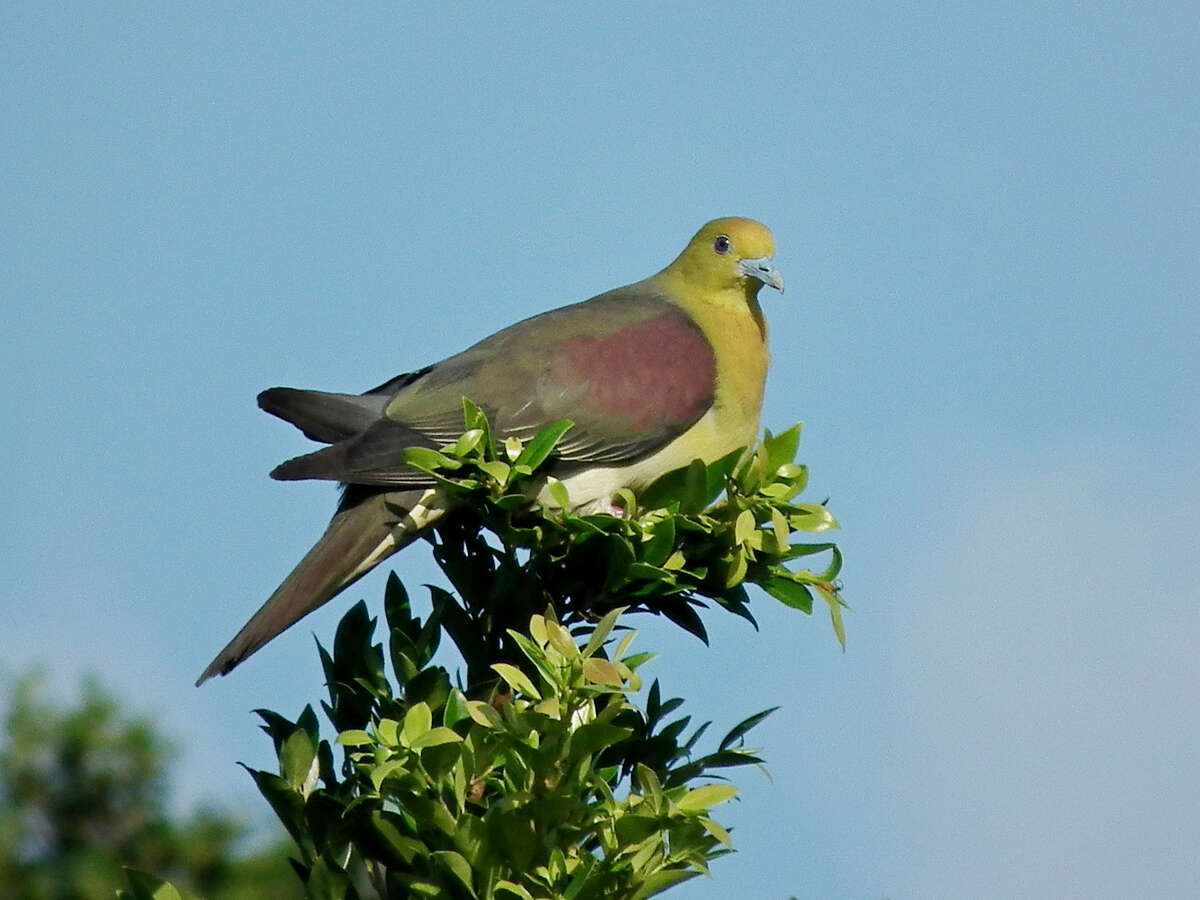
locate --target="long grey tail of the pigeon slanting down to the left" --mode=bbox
[196,491,445,686]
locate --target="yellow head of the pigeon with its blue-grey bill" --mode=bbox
[659,218,784,296]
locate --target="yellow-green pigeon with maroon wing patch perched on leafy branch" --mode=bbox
[196,217,784,686]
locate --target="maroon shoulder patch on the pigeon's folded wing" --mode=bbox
[551,310,716,432]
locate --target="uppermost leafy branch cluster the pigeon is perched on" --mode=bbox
[398,401,845,682]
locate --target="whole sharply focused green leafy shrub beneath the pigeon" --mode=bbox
[138,403,845,900]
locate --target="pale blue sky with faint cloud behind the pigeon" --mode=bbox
[0,7,1200,900]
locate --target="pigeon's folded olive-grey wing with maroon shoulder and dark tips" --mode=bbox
[259,286,716,487]
